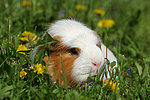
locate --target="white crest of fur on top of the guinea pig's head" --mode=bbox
[47,19,94,45]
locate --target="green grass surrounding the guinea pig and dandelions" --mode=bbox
[0,0,150,100]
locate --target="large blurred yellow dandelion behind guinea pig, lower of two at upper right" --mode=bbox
[98,19,115,28]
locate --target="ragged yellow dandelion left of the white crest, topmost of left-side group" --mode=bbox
[19,31,39,44]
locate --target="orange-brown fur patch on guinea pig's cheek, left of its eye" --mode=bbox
[44,42,78,86]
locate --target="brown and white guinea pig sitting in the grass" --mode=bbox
[31,19,117,86]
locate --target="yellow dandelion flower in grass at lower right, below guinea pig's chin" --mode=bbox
[103,79,119,92]
